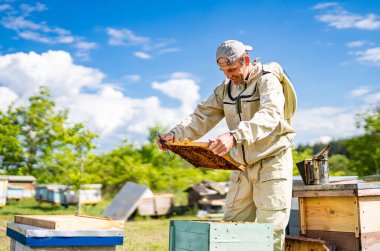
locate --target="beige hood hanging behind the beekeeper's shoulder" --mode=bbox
[263,62,297,124]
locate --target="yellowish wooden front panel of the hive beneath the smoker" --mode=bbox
[301,197,357,233]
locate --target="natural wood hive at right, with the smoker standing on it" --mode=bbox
[293,182,380,251]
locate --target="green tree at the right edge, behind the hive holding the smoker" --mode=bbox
[345,108,380,176]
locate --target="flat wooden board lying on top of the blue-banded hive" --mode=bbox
[15,215,123,230]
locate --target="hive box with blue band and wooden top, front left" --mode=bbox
[7,215,123,251]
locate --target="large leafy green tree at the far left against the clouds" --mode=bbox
[0,86,97,184]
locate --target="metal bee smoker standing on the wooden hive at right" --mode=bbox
[296,145,330,185]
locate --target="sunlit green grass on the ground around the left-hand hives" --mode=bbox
[0,198,194,251]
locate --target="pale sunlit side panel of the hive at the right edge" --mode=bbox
[359,196,380,233]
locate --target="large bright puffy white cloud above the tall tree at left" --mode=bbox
[0,51,104,96]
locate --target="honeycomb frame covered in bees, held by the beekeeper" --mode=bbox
[166,140,245,171]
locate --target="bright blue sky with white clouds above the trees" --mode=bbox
[0,0,380,153]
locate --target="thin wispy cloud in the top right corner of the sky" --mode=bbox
[314,4,380,30]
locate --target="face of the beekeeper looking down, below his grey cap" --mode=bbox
[218,58,248,84]
